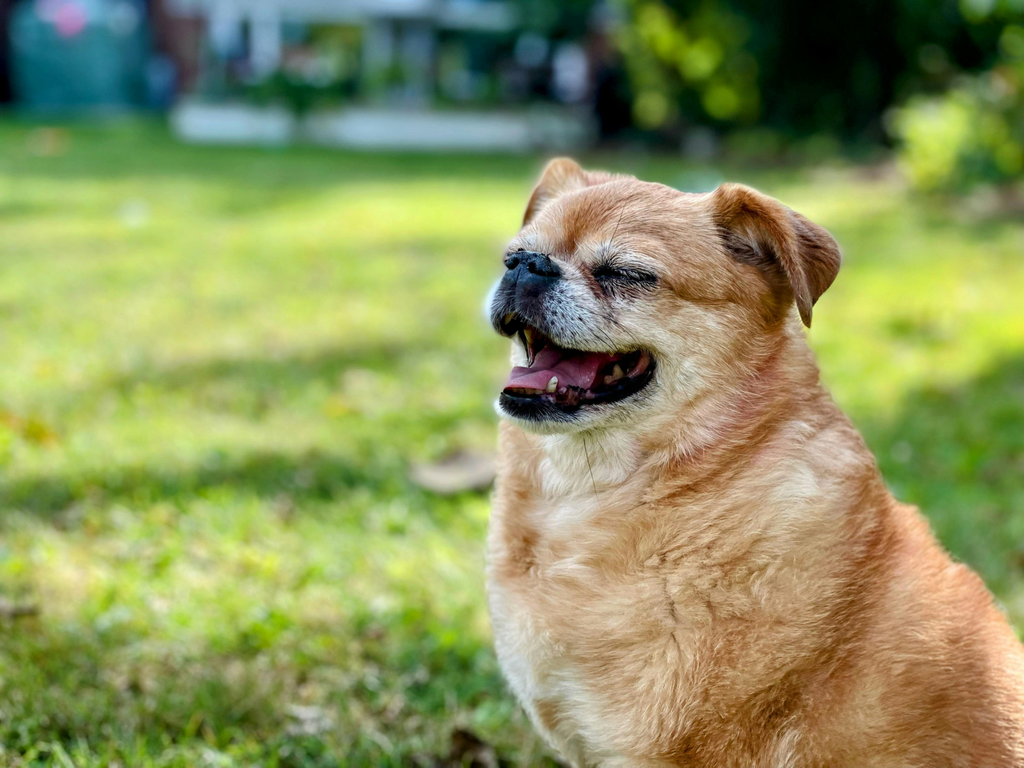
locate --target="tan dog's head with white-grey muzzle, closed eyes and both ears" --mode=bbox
[490,159,840,432]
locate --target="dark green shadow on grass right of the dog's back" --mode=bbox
[858,356,1024,593]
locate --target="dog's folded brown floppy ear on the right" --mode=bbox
[712,184,842,328]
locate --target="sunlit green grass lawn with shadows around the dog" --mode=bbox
[0,123,1024,768]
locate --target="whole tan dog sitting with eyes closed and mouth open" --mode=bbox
[488,160,1024,768]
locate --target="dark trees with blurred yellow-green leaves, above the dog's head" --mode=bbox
[622,0,1015,139]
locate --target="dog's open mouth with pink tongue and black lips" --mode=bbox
[501,314,654,415]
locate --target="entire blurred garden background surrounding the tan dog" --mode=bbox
[0,0,1024,768]
